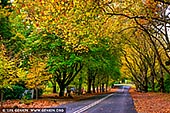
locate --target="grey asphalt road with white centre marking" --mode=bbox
[57,86,137,113]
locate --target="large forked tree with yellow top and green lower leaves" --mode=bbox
[14,0,113,96]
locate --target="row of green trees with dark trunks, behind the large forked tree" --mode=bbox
[86,39,120,93]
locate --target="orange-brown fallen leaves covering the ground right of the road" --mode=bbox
[130,89,170,113]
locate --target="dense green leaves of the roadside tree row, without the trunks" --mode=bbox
[86,38,120,79]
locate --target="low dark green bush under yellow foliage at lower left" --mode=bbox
[4,85,25,100]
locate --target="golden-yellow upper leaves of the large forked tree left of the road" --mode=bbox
[12,0,111,50]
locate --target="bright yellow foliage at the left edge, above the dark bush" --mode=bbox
[0,45,24,89]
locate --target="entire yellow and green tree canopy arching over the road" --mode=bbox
[0,0,170,100]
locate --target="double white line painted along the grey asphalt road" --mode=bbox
[73,93,113,113]
